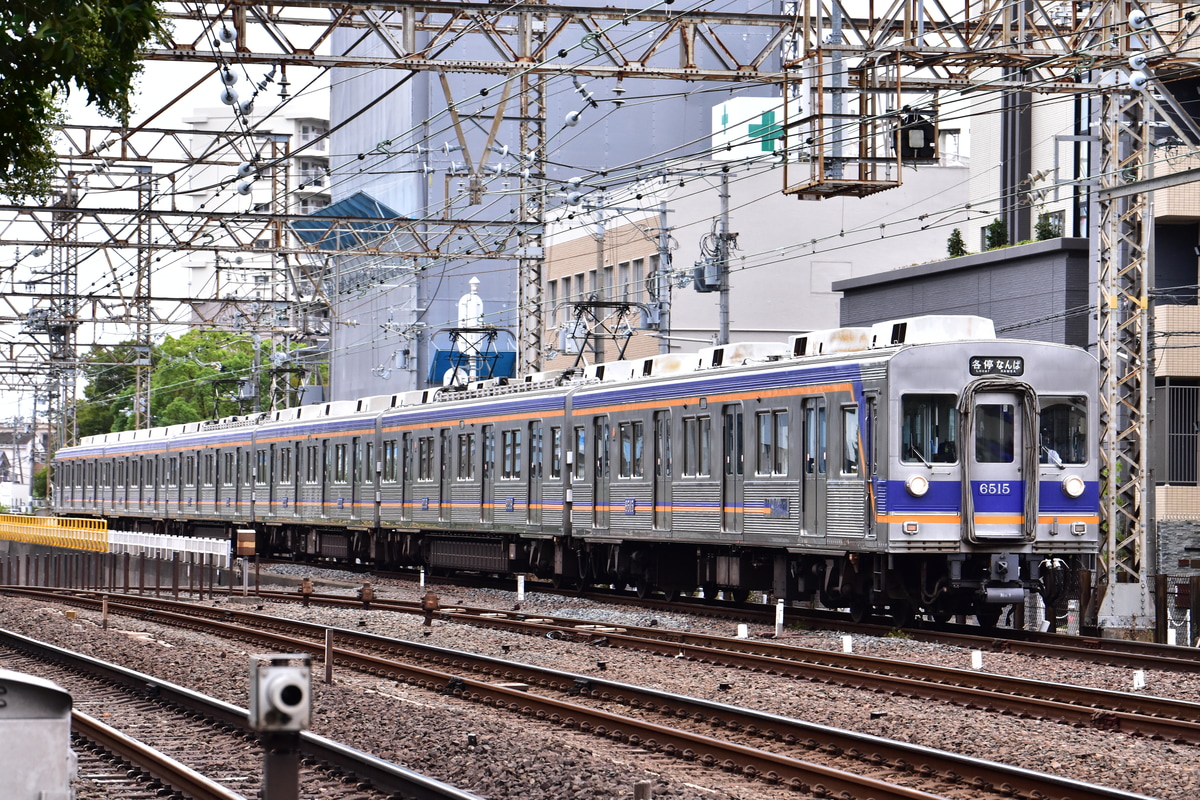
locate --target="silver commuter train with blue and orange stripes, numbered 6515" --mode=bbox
[54,317,1099,624]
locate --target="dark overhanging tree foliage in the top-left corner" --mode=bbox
[0,0,166,200]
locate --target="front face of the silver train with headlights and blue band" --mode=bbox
[875,331,1099,625]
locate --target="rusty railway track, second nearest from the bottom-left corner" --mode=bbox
[4,587,1156,800]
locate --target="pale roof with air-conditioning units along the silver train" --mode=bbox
[63,314,1012,446]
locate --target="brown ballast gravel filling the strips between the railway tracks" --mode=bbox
[0,566,1200,800]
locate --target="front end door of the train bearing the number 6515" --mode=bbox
[965,391,1037,539]
